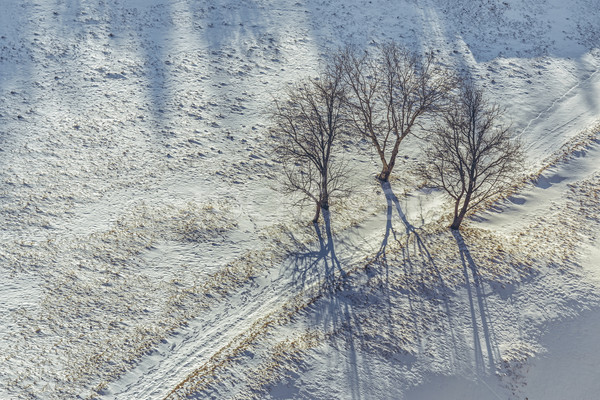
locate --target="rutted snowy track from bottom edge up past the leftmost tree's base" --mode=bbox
[102,208,387,399]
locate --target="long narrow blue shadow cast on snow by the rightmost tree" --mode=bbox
[452,231,500,373]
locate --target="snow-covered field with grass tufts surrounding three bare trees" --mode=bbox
[0,0,600,399]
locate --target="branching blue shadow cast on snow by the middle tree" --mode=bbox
[369,183,459,378]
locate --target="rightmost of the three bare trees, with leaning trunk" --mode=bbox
[421,79,524,230]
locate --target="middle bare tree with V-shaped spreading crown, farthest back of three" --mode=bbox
[335,43,455,182]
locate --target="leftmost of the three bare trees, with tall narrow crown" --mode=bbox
[272,70,347,223]
